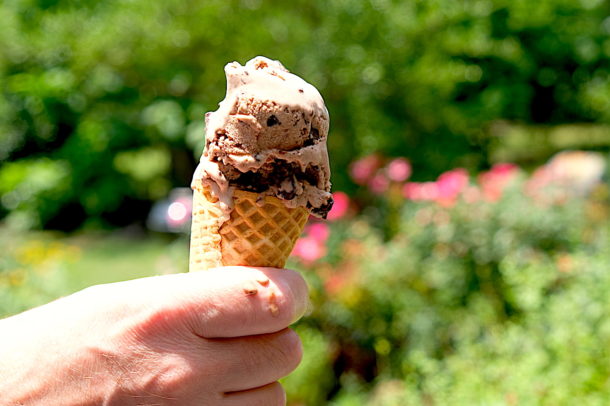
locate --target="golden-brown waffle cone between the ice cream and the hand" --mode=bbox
[189,187,309,272]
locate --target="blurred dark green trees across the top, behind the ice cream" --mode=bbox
[0,0,610,229]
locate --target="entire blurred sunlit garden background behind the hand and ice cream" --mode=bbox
[0,0,610,406]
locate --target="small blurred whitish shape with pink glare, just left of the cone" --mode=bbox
[146,188,193,234]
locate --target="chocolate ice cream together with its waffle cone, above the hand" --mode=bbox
[189,56,333,271]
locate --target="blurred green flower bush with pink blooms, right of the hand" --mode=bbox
[289,155,610,405]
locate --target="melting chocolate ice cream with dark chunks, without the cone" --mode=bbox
[193,56,332,217]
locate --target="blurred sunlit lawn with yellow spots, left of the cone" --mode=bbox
[0,228,188,317]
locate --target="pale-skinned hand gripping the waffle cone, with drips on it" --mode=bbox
[0,267,308,406]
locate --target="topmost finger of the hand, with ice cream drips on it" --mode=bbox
[175,267,309,338]
